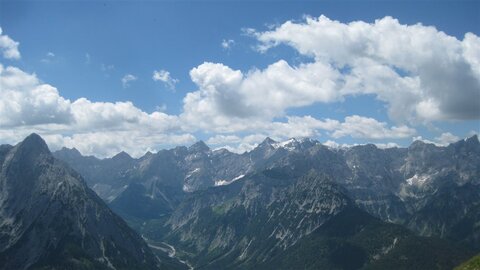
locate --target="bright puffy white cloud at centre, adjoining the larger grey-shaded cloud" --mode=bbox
[183,60,341,128]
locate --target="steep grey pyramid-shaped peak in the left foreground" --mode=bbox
[0,134,164,269]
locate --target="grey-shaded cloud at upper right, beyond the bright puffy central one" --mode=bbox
[253,16,480,122]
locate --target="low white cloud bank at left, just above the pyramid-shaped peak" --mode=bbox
[0,65,191,157]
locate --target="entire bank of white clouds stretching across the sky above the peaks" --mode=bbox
[0,16,480,157]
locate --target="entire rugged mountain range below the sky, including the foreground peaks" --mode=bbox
[0,134,480,269]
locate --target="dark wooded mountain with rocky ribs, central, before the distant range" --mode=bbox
[162,168,468,269]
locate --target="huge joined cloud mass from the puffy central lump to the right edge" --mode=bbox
[182,16,480,132]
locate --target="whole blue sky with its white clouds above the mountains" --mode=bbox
[0,0,480,158]
